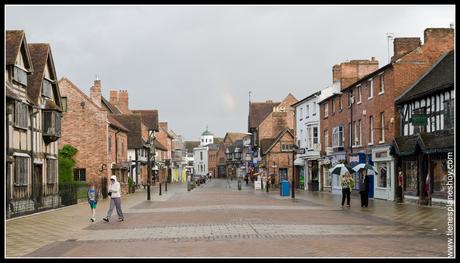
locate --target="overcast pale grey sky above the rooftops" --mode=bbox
[5,5,455,140]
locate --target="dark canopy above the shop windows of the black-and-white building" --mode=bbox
[393,130,454,156]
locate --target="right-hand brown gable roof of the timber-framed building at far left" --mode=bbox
[27,43,62,111]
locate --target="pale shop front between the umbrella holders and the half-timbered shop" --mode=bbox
[372,146,396,201]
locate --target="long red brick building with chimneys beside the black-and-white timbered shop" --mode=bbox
[320,28,454,200]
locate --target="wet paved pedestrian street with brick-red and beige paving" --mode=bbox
[6,179,447,257]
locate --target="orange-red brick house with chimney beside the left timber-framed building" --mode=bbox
[59,78,128,196]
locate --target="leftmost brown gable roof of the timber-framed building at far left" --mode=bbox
[5,30,34,72]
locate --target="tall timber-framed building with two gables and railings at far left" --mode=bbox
[5,30,62,217]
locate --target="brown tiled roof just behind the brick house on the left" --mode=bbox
[110,114,144,149]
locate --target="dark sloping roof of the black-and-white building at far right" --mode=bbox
[395,50,454,104]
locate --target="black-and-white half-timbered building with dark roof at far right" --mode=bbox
[393,50,455,204]
